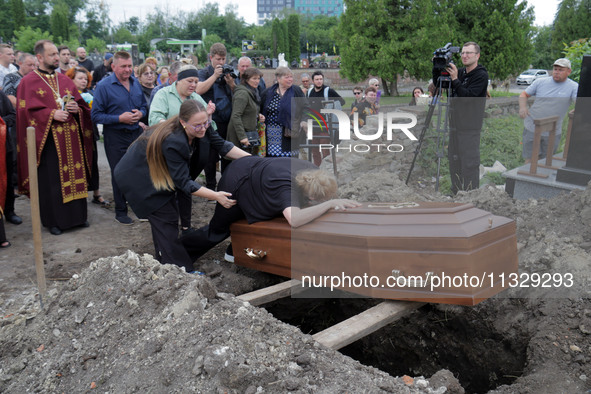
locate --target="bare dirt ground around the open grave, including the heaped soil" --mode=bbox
[0,141,591,394]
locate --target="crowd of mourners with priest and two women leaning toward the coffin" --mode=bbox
[0,40,358,272]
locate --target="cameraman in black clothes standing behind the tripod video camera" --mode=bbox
[446,42,488,195]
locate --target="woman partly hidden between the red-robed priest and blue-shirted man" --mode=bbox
[66,66,111,208]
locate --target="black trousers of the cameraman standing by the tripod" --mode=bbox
[448,130,480,195]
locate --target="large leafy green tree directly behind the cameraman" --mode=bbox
[336,0,533,95]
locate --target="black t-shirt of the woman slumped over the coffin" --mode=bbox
[218,156,318,224]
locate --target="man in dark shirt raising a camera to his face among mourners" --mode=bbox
[195,42,238,190]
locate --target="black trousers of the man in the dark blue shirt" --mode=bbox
[103,128,142,216]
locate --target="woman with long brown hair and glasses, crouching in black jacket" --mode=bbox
[115,100,248,272]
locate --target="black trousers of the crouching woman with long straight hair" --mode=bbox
[148,199,193,272]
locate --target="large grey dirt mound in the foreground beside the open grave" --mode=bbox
[0,252,458,393]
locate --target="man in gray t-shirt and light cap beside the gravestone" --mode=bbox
[519,58,579,163]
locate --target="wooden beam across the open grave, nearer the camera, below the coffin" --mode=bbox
[312,301,425,350]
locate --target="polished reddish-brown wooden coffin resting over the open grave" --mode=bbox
[231,202,518,305]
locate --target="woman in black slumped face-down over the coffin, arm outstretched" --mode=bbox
[182,156,360,262]
